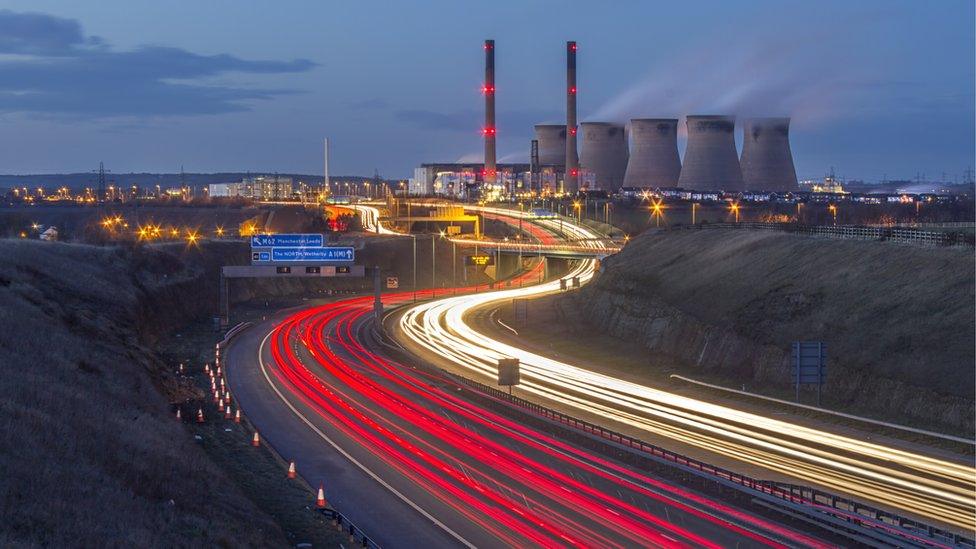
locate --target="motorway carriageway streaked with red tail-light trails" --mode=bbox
[224,209,825,547]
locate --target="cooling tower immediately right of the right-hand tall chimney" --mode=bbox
[580,122,628,191]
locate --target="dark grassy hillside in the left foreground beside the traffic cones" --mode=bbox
[0,240,287,547]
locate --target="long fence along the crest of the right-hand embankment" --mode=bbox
[688,222,976,246]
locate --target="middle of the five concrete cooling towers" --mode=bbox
[624,118,681,187]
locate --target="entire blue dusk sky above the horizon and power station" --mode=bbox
[0,0,976,180]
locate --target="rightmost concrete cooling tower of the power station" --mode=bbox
[740,118,799,191]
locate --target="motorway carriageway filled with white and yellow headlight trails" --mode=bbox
[392,206,976,533]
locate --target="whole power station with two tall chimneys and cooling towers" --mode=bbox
[412,40,798,200]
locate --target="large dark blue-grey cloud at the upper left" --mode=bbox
[0,10,315,118]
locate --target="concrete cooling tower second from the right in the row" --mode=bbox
[678,116,745,191]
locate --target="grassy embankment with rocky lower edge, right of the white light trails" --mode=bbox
[566,230,976,434]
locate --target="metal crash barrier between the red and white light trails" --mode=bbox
[450,374,976,548]
